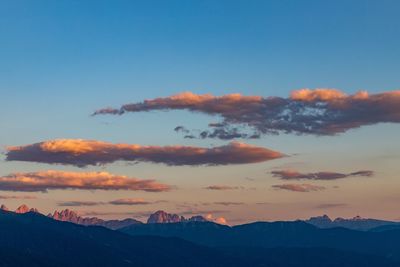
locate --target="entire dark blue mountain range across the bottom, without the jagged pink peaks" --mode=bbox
[0,210,400,267]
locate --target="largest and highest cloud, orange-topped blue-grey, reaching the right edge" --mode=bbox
[93,89,400,139]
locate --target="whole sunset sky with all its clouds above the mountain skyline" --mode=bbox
[0,0,400,224]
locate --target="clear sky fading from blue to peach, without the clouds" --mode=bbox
[0,0,400,224]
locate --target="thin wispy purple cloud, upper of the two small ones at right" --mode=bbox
[271,170,374,180]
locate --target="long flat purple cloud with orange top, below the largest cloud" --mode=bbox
[6,139,284,167]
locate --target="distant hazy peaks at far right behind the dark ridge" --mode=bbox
[305,215,399,231]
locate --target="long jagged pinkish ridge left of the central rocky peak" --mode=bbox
[47,209,142,230]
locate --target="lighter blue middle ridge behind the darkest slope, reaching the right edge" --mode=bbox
[120,221,400,261]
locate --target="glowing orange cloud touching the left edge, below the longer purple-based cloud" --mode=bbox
[0,170,171,192]
